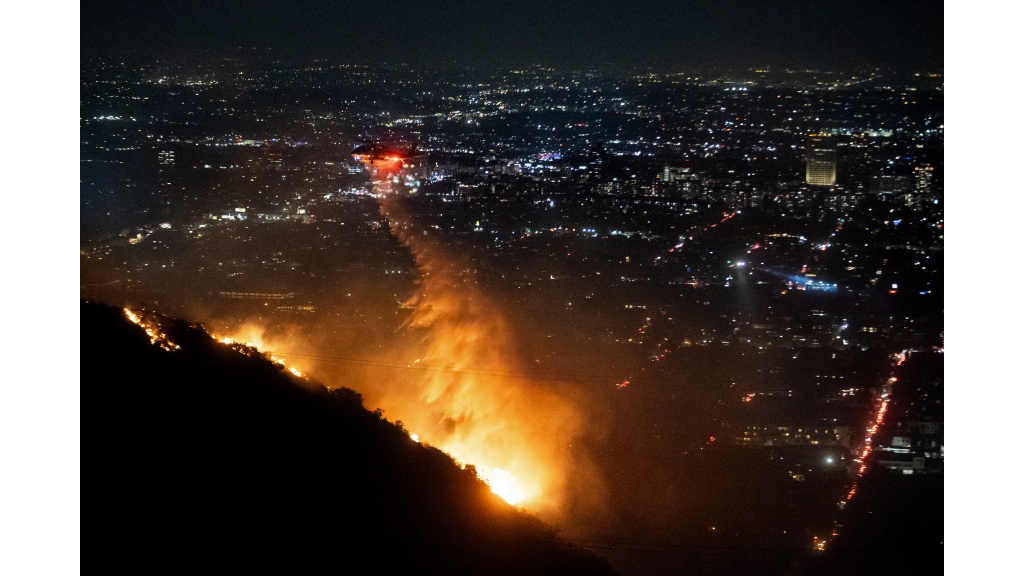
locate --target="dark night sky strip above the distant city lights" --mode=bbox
[81,0,943,71]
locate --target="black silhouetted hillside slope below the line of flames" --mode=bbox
[81,302,611,574]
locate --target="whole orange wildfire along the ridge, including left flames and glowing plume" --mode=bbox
[124,242,580,512]
